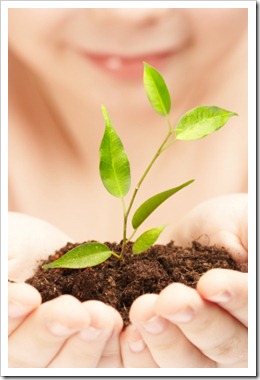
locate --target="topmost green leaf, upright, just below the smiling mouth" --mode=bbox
[143,62,171,116]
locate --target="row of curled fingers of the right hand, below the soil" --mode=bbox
[121,269,247,368]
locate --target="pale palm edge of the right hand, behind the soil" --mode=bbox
[172,193,248,263]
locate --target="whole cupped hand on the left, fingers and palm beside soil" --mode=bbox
[9,213,122,368]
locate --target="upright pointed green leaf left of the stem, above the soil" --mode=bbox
[99,106,131,198]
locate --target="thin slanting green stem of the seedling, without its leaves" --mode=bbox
[120,118,174,257]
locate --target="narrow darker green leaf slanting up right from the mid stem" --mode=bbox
[132,179,194,229]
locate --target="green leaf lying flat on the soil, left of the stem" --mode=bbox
[43,242,112,269]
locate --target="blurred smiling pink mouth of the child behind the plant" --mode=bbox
[77,51,174,80]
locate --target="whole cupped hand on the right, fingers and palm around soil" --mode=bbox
[121,194,248,368]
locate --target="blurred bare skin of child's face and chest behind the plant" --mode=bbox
[9,9,247,241]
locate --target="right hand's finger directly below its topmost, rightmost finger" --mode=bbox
[155,283,247,367]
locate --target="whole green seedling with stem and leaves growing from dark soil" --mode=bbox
[43,63,237,268]
